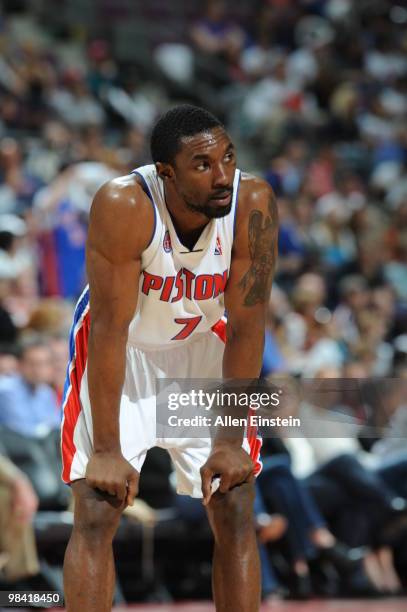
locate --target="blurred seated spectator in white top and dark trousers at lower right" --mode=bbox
[286,368,407,592]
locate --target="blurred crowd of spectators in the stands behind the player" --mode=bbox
[0,0,407,597]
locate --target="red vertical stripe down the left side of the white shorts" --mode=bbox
[61,311,90,483]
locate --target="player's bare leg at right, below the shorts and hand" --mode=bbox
[207,482,261,612]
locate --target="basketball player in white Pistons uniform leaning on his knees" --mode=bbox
[62,105,277,612]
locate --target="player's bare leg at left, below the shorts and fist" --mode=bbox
[64,480,124,612]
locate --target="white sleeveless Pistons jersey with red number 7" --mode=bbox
[128,164,240,349]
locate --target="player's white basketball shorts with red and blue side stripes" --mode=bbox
[61,293,261,497]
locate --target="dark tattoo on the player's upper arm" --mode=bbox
[239,182,278,306]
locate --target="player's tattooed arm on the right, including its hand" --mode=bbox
[201,178,278,504]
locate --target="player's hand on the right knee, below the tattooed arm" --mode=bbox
[201,441,254,506]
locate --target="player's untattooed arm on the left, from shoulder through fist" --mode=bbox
[86,177,154,503]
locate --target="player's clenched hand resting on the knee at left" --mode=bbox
[85,451,140,506]
